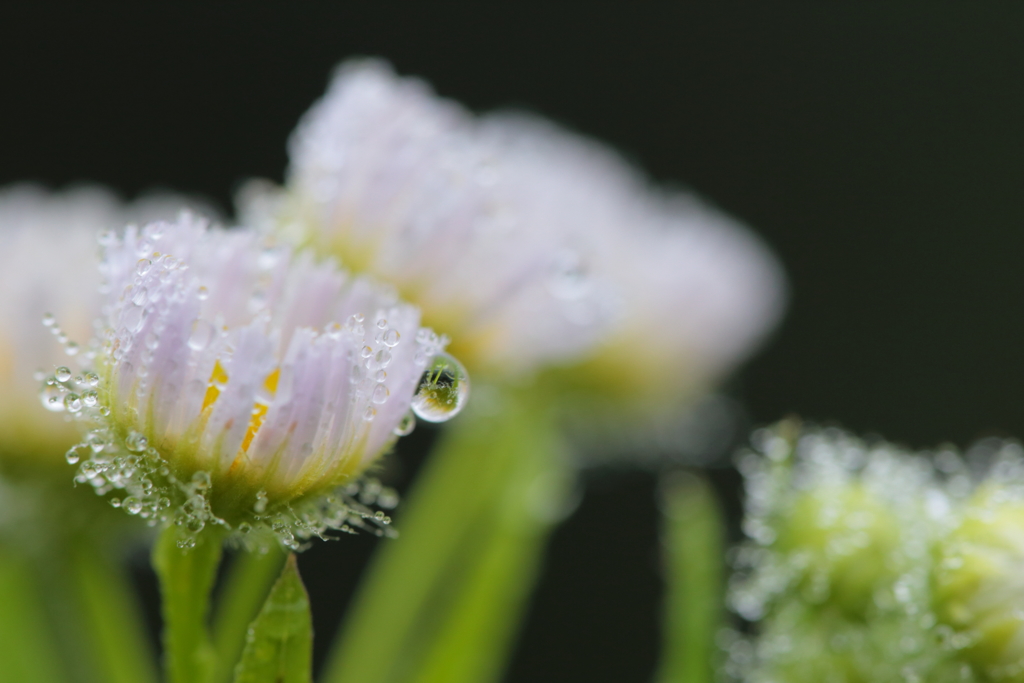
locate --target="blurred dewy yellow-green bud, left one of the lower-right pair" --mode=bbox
[733,422,933,621]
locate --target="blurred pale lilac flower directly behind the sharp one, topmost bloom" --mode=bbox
[243,61,604,377]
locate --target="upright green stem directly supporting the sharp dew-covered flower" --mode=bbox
[153,526,223,683]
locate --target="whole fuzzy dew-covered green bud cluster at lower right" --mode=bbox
[731,423,1024,683]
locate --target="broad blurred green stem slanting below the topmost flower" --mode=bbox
[323,395,570,683]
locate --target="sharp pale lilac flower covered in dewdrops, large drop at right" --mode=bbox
[68,216,467,545]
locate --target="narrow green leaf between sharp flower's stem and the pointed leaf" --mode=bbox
[213,546,285,683]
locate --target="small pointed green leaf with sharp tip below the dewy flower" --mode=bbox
[234,555,313,683]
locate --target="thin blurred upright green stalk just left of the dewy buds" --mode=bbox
[657,473,725,683]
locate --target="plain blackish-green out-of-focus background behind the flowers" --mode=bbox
[0,3,1024,683]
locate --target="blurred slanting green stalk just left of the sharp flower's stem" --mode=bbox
[69,543,157,683]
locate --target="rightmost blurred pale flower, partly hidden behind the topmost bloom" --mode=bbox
[471,114,784,411]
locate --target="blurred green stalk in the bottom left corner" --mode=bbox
[0,548,67,683]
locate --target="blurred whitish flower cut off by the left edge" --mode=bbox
[0,184,208,473]
